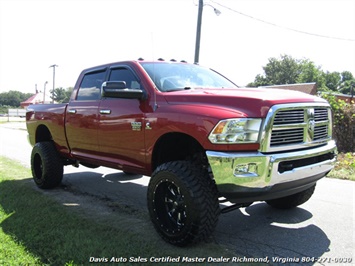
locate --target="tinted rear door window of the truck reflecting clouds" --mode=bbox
[76,71,105,101]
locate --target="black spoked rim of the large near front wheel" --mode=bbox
[154,180,188,234]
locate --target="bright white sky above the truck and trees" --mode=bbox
[0,0,355,93]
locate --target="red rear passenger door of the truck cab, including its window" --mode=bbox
[65,70,106,159]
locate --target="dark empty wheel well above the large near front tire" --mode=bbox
[152,133,204,171]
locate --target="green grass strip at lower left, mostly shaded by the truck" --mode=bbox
[0,157,235,266]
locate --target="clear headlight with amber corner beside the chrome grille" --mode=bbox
[208,118,261,144]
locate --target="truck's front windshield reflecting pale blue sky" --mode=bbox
[141,62,237,92]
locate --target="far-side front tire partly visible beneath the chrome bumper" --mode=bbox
[266,185,316,209]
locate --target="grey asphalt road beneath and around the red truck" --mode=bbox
[0,123,355,265]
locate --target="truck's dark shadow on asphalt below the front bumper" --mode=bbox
[214,202,330,265]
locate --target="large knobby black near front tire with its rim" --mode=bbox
[147,161,220,246]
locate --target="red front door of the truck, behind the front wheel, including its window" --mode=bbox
[98,66,145,172]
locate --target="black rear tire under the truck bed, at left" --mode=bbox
[31,141,63,189]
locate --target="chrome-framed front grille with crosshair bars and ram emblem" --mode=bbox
[262,104,331,151]
